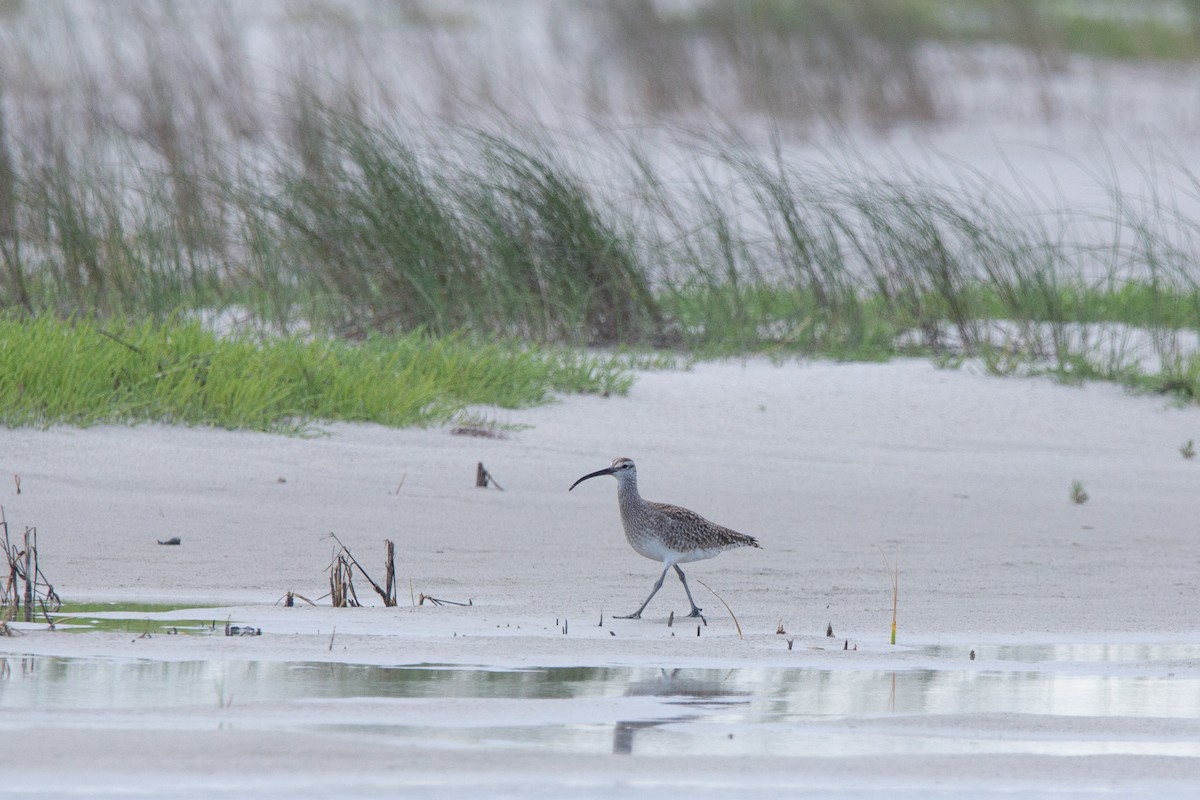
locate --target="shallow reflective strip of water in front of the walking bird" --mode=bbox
[0,644,1200,758]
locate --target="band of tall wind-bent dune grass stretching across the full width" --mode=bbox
[0,97,1200,393]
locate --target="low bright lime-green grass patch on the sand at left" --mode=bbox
[0,315,631,432]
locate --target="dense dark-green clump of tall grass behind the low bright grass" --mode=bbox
[240,108,661,344]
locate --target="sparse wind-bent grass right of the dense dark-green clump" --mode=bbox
[638,131,1200,387]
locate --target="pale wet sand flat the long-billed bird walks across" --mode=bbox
[0,360,1200,796]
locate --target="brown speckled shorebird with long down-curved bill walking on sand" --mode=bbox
[568,458,760,619]
